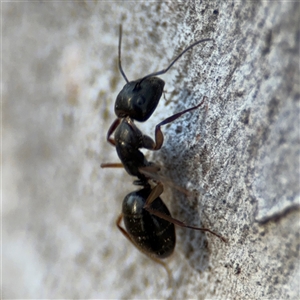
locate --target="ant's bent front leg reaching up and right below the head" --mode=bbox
[143,96,207,150]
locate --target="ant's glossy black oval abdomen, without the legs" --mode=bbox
[122,187,176,258]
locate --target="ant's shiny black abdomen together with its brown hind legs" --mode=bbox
[117,183,226,264]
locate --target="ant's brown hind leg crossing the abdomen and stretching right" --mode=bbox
[144,183,227,243]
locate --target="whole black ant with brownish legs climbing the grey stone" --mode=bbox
[101,25,226,275]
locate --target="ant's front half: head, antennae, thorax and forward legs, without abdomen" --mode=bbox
[102,26,211,185]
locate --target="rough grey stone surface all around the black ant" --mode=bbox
[2,1,300,299]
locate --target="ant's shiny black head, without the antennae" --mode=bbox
[115,77,165,122]
